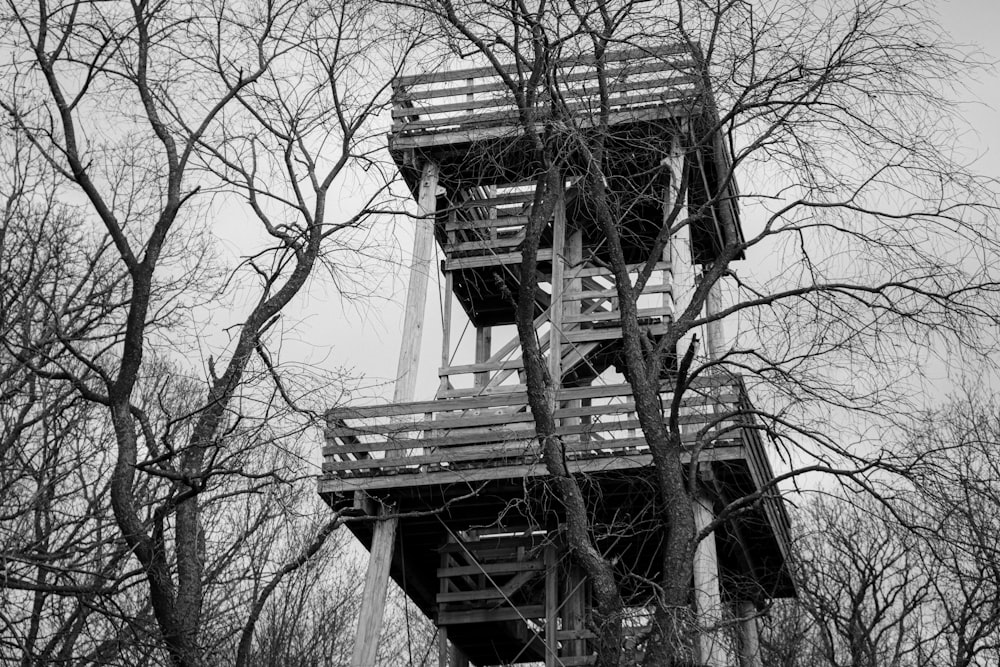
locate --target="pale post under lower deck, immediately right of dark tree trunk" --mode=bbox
[692,495,727,667]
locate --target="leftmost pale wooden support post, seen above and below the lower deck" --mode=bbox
[351,162,439,667]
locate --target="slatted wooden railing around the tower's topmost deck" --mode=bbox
[390,45,699,149]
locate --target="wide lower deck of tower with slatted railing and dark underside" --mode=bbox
[320,377,794,665]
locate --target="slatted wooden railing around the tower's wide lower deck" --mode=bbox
[322,377,752,492]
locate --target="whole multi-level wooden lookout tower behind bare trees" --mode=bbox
[319,47,794,667]
